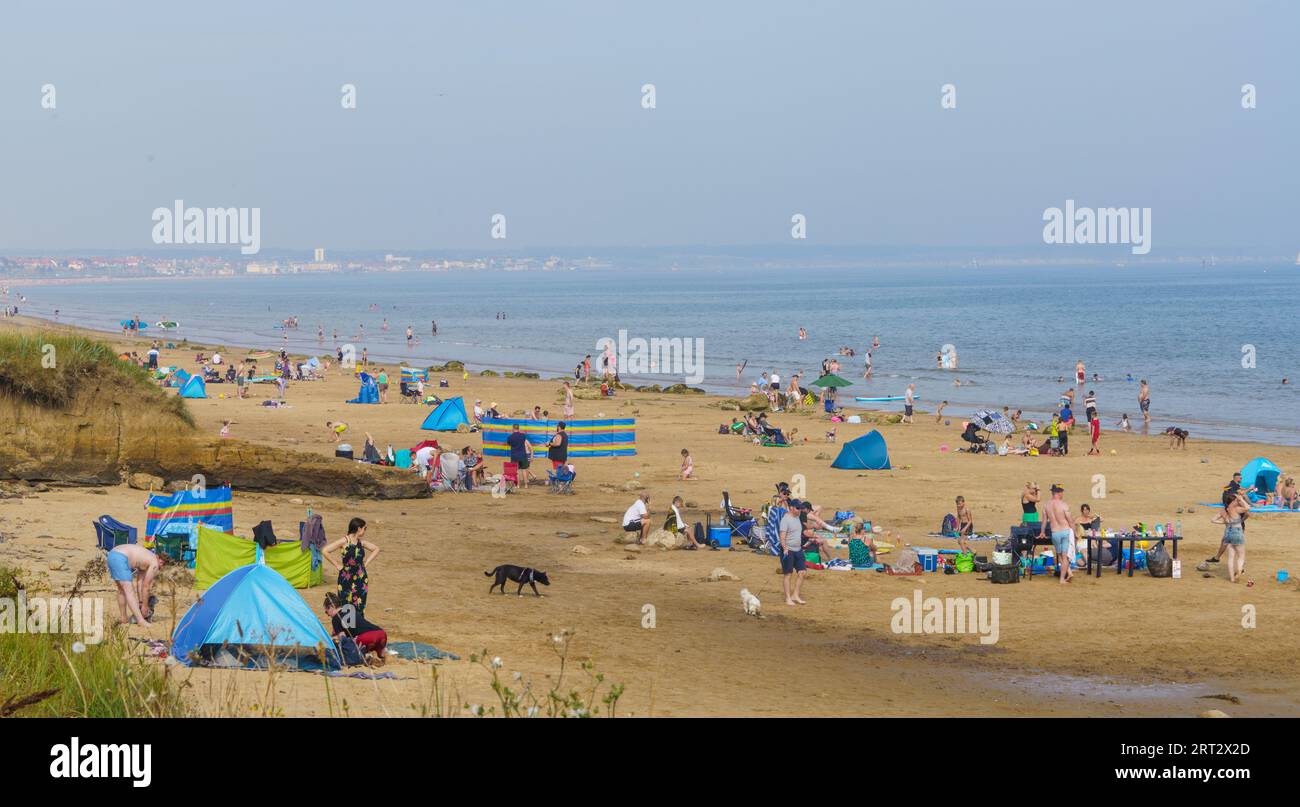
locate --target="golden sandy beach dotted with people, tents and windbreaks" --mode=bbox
[0,321,1300,716]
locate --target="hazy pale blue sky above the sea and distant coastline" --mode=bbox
[0,0,1300,256]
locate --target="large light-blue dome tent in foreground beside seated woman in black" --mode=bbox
[172,563,341,669]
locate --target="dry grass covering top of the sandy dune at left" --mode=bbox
[0,333,194,426]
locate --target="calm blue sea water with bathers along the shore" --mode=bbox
[13,264,1300,444]
